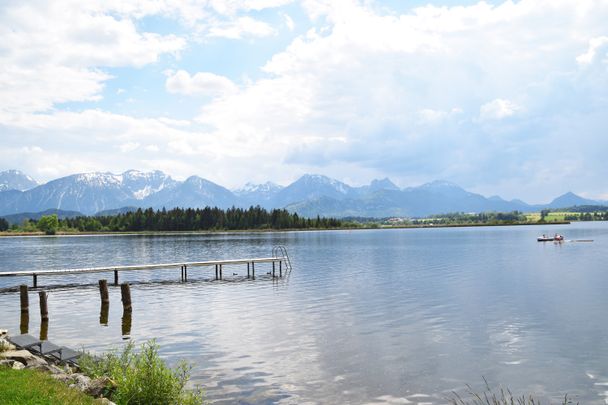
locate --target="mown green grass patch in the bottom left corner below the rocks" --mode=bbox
[0,367,96,405]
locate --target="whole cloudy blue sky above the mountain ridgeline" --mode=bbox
[0,0,608,203]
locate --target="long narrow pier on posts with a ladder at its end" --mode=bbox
[0,246,291,288]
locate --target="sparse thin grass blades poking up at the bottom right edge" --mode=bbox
[448,378,578,405]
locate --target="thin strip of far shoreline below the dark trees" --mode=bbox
[0,221,571,237]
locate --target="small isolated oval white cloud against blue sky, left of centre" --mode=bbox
[165,70,238,96]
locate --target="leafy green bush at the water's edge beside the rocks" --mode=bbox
[80,340,203,405]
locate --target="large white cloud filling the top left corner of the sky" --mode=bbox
[0,2,185,113]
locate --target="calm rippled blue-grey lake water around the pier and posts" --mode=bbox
[0,223,608,404]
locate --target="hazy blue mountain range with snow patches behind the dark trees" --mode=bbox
[0,170,608,218]
